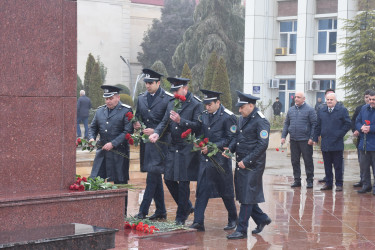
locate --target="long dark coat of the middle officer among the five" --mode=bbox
[155,92,203,181]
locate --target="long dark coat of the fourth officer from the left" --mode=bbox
[197,106,237,198]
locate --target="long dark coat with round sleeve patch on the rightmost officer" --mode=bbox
[229,108,270,204]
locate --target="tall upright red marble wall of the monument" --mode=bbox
[0,0,77,195]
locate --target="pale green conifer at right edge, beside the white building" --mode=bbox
[340,7,375,110]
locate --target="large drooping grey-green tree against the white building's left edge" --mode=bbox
[172,0,245,109]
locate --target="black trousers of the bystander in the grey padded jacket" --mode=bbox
[290,140,314,182]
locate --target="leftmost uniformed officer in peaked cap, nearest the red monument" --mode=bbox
[89,85,133,184]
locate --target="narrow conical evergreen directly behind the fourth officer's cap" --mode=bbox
[211,57,232,110]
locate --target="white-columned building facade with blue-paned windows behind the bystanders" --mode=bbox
[244,0,358,116]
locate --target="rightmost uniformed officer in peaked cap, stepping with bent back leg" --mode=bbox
[227,91,271,239]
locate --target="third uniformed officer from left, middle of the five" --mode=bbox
[150,77,203,225]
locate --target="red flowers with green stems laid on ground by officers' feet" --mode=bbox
[124,217,189,234]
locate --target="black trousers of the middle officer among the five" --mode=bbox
[164,179,193,222]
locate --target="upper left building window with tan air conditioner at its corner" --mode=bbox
[280,21,297,54]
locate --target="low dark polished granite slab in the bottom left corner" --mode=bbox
[0,223,118,250]
